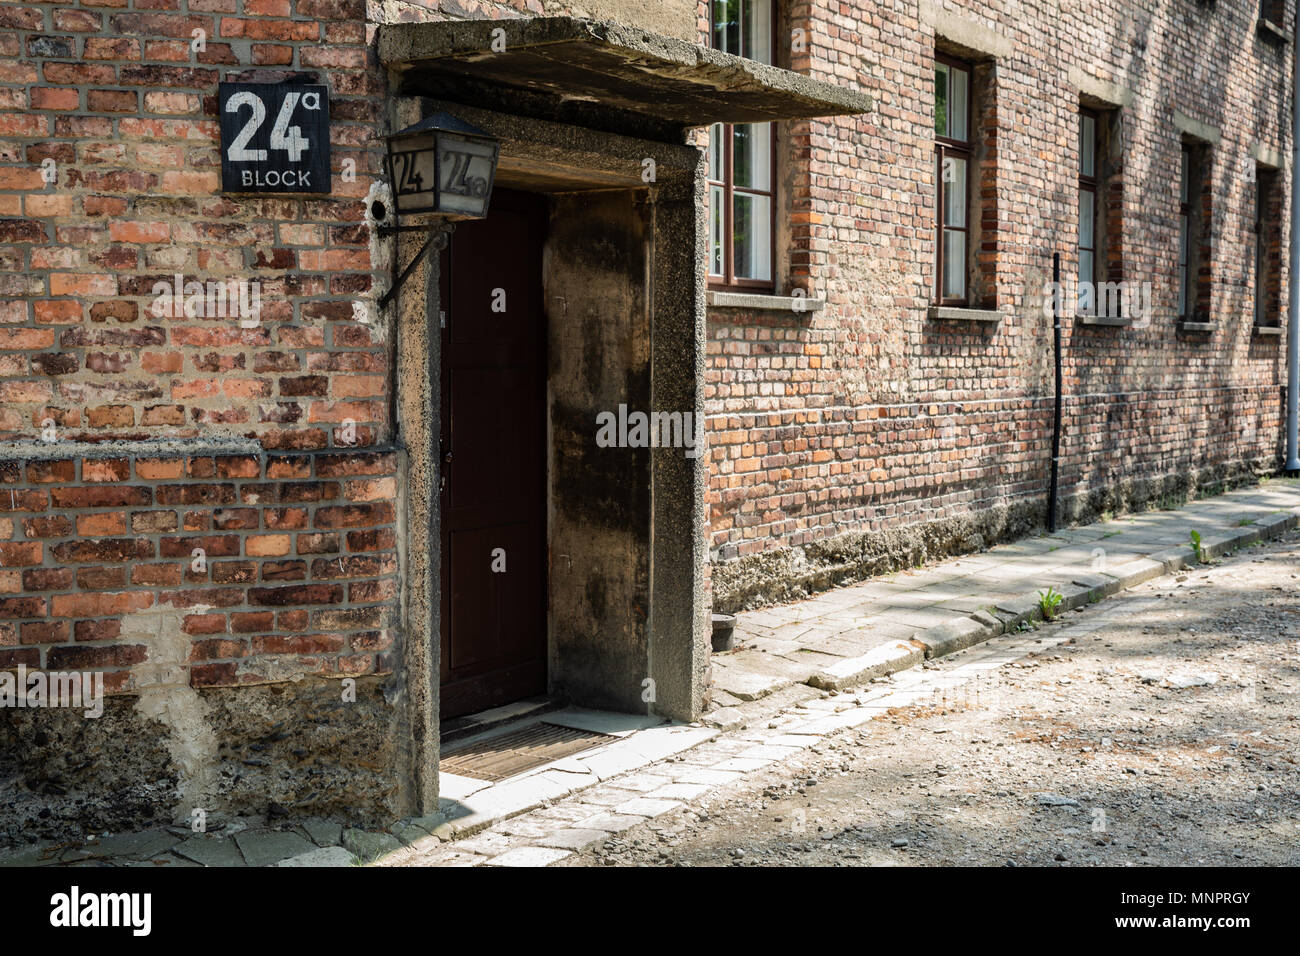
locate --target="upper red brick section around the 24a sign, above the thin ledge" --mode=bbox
[0,0,390,449]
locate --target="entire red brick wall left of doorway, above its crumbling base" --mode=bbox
[0,0,399,692]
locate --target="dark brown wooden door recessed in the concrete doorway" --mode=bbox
[441,190,546,718]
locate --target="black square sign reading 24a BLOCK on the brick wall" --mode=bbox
[217,83,330,193]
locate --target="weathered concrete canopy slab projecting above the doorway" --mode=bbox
[378,17,871,140]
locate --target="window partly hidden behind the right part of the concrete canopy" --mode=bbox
[709,0,776,289]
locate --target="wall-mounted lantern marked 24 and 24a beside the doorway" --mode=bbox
[378,113,501,308]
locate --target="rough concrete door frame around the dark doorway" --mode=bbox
[389,96,710,813]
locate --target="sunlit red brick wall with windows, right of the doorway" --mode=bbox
[706,0,1295,582]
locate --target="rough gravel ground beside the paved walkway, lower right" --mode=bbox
[559,532,1300,866]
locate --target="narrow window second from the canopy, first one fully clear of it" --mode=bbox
[935,55,972,306]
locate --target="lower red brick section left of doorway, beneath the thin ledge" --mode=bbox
[0,451,398,692]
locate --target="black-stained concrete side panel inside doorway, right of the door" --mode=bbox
[543,191,650,710]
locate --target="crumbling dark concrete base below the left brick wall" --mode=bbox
[0,678,402,845]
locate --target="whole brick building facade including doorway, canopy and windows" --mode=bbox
[0,0,1295,839]
